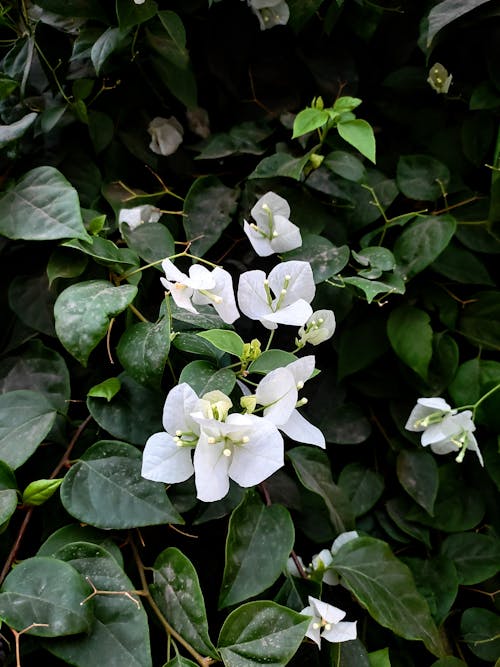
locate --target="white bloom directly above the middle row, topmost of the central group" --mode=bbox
[243,192,302,257]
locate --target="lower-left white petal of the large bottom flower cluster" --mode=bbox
[141,433,193,484]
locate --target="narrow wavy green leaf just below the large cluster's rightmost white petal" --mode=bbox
[287,446,354,533]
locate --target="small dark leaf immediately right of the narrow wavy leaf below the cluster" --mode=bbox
[338,463,385,518]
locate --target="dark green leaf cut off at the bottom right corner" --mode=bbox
[460,607,500,662]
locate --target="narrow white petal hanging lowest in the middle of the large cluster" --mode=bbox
[193,431,231,503]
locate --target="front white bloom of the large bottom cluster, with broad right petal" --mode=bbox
[191,397,284,502]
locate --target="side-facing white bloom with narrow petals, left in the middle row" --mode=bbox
[160,259,240,324]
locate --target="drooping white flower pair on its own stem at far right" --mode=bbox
[405,397,484,465]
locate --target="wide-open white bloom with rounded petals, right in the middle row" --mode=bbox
[238,260,316,329]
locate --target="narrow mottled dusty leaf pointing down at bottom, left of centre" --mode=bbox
[151,547,218,659]
